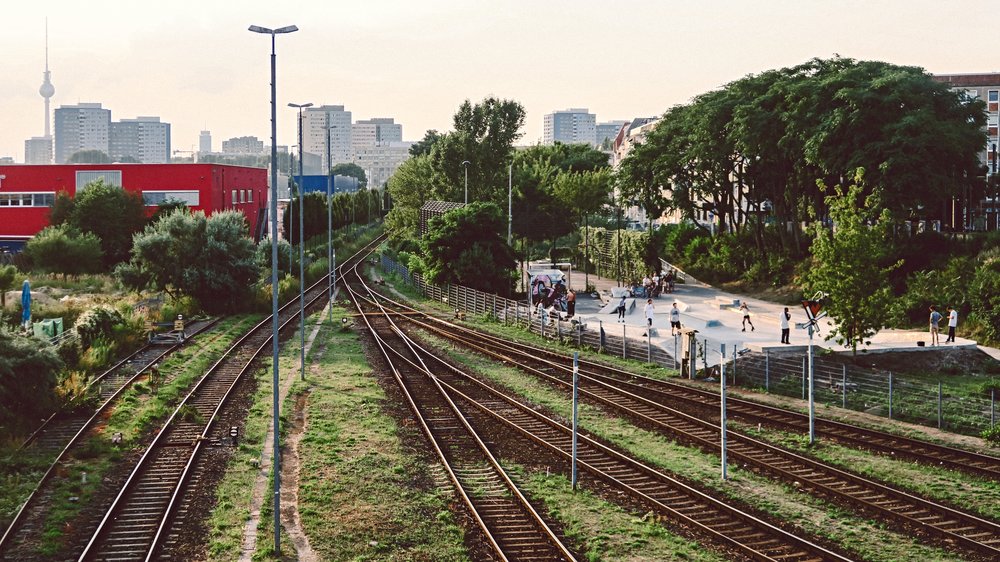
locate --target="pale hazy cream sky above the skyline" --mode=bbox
[0,0,1000,162]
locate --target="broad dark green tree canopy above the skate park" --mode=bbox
[618,57,985,254]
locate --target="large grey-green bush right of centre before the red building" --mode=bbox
[115,210,258,313]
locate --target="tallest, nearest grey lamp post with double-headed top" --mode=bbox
[250,20,299,552]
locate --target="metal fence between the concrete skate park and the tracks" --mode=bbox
[380,255,675,369]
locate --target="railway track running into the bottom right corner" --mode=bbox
[368,286,1000,559]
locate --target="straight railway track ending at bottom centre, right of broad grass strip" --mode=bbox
[349,275,576,561]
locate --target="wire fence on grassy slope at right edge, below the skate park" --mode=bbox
[727,352,996,435]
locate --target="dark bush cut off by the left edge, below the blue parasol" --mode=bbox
[0,326,63,427]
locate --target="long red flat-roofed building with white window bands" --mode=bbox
[0,164,267,249]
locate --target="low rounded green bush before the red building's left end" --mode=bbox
[24,224,103,277]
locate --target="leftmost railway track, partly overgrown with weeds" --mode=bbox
[0,319,218,554]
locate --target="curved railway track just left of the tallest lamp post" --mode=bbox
[60,234,381,561]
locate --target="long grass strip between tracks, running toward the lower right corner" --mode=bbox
[429,332,961,562]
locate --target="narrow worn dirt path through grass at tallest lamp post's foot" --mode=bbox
[240,307,330,562]
